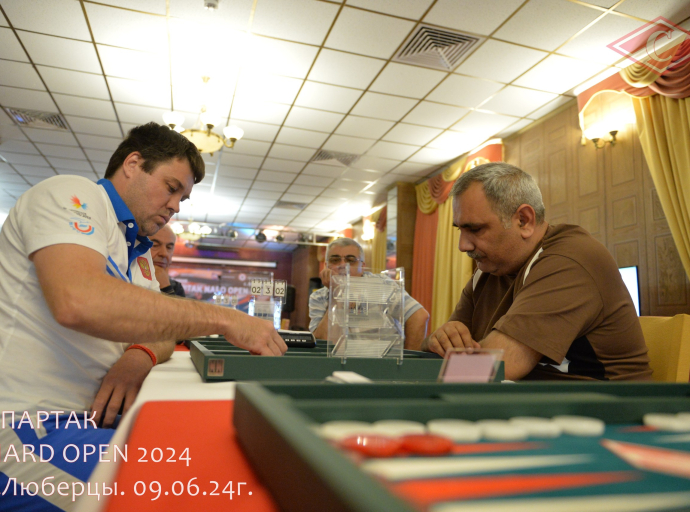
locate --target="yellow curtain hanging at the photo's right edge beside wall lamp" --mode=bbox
[633,94,690,276]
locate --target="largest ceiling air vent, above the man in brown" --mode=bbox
[393,25,484,71]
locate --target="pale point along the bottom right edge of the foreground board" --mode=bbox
[429,492,690,512]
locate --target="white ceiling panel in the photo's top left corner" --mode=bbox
[2,0,91,41]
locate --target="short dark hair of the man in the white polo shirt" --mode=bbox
[105,122,206,183]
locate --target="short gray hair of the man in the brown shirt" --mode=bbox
[449,162,545,228]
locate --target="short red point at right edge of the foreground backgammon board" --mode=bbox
[601,439,690,478]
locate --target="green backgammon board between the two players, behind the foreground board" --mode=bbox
[190,337,504,382]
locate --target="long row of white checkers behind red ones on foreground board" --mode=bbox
[313,415,606,443]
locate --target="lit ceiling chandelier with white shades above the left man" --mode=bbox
[163,76,244,155]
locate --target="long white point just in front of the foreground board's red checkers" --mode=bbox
[362,455,592,481]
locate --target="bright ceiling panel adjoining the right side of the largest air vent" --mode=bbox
[455,39,548,83]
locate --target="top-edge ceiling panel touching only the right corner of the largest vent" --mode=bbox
[494,0,603,51]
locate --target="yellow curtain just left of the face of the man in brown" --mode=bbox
[429,196,472,332]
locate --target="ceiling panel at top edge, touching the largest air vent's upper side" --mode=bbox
[424,0,523,35]
